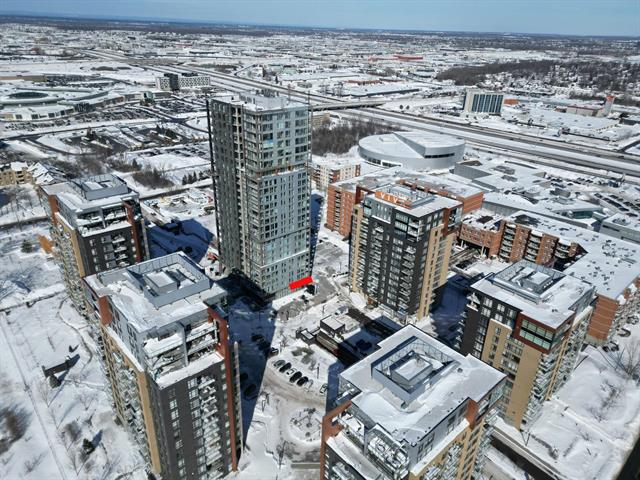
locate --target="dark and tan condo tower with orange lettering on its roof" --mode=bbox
[349,184,462,322]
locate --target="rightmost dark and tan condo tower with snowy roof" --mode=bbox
[458,260,594,428]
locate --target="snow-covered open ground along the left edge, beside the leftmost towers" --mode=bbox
[0,227,146,480]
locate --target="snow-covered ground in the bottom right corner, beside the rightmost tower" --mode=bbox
[499,324,640,480]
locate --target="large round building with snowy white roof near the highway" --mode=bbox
[358,131,465,170]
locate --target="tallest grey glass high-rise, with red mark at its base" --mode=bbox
[211,95,311,297]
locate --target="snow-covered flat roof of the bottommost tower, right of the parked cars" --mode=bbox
[340,325,504,443]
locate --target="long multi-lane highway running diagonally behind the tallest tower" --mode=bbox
[83,50,640,183]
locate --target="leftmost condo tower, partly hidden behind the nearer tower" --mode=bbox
[40,174,149,315]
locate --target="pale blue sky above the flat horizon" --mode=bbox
[0,0,640,36]
